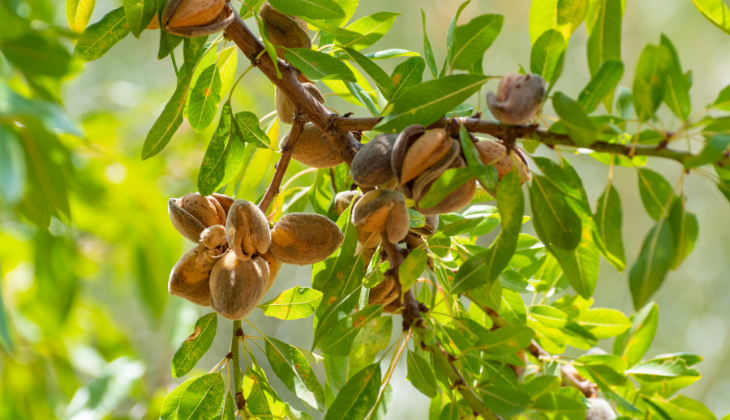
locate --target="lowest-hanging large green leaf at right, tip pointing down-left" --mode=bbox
[629,219,673,308]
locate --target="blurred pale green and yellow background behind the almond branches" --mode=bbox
[0,0,730,419]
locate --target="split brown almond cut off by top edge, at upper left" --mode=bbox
[162,0,236,38]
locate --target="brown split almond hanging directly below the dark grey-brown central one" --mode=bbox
[352,189,409,244]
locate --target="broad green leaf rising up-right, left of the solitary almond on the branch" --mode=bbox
[450,15,504,70]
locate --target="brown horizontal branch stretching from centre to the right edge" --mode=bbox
[333,117,730,165]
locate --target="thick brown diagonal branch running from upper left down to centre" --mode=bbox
[225,10,361,165]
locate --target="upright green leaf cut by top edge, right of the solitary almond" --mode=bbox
[587,0,623,76]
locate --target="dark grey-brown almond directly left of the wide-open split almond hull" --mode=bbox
[350,134,398,188]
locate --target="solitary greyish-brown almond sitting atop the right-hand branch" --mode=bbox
[487,73,546,125]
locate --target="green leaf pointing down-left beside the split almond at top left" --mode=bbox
[74,7,129,61]
